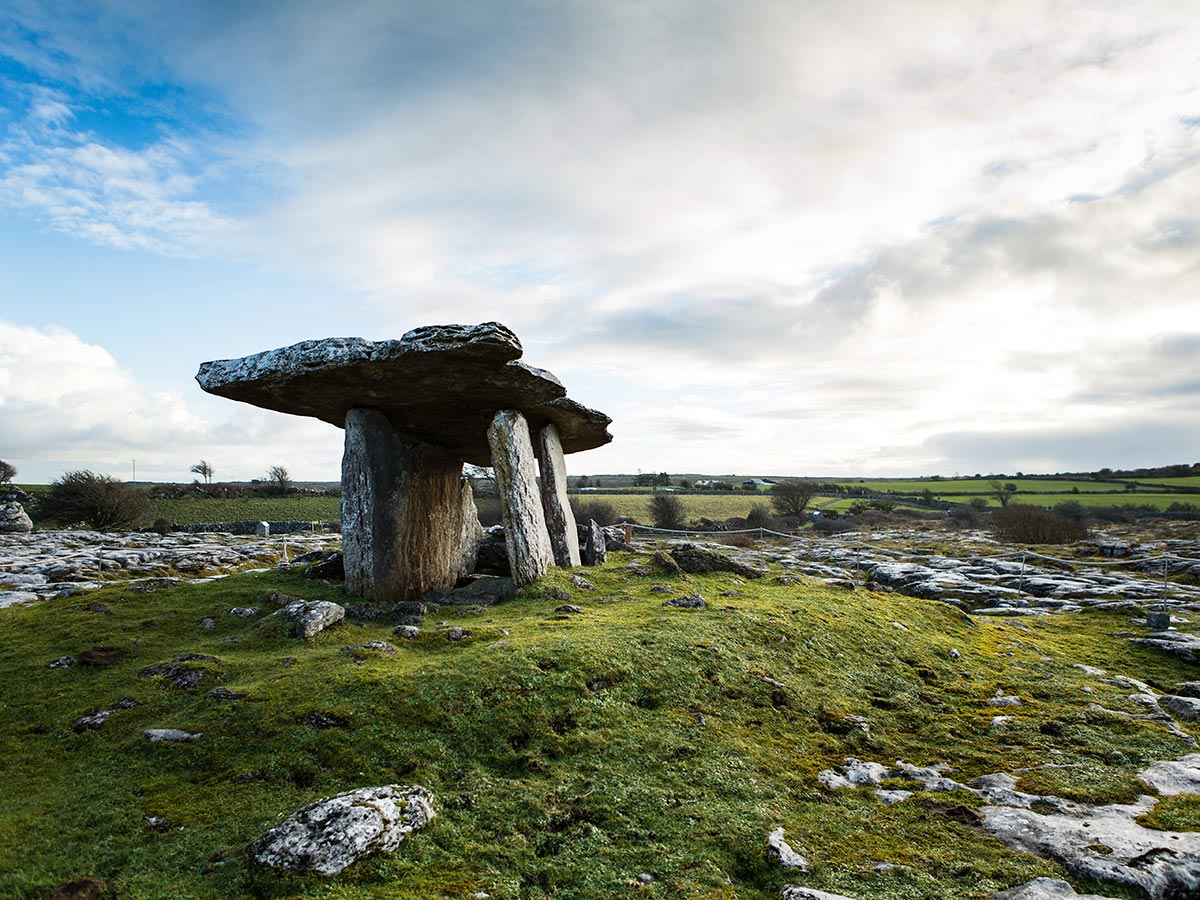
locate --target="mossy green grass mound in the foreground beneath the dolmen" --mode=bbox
[0,554,1200,900]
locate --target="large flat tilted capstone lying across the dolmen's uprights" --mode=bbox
[196,322,612,466]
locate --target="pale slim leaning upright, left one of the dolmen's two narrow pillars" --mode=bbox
[487,409,554,584]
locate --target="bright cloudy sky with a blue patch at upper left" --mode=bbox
[0,0,1200,482]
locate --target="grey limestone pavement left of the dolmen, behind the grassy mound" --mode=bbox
[0,532,341,608]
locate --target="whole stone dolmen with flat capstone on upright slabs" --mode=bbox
[196,322,612,602]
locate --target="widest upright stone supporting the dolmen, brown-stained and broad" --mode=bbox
[342,409,463,602]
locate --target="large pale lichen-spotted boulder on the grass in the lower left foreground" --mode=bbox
[250,785,436,875]
